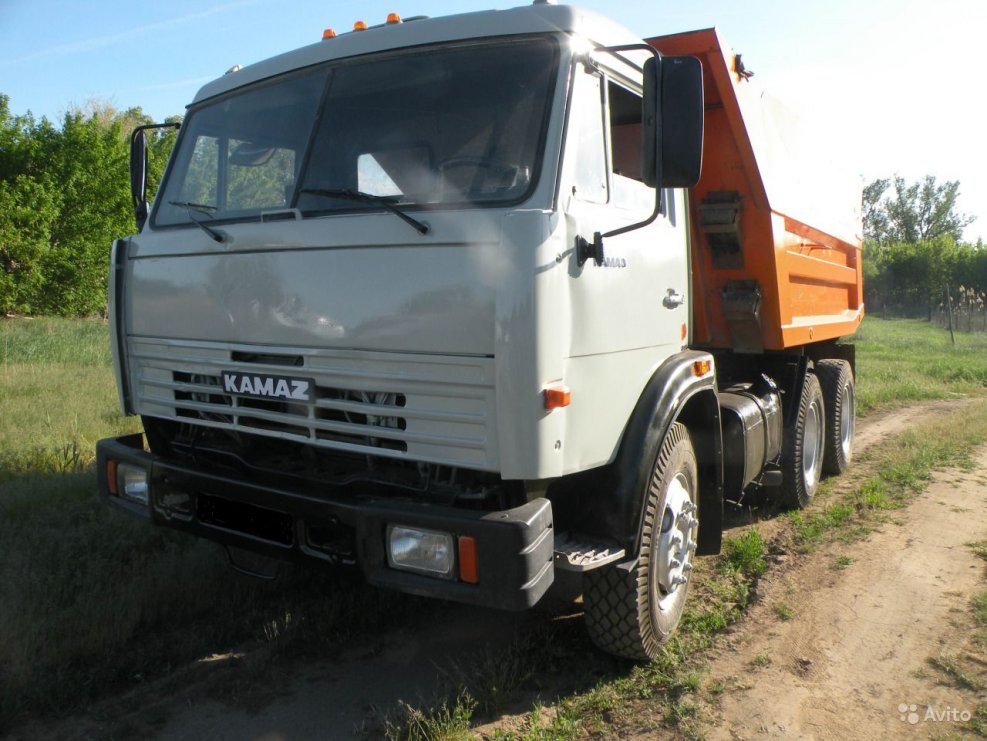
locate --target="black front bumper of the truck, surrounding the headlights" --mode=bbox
[96,435,554,610]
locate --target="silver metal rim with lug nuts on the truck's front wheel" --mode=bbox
[656,473,699,610]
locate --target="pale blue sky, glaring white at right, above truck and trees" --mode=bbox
[0,0,987,241]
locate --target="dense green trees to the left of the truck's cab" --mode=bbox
[0,94,174,316]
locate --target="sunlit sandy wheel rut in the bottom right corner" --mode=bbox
[709,451,987,741]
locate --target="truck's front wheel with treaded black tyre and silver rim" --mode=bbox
[583,422,699,659]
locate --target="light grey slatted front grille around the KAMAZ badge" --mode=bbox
[129,338,497,470]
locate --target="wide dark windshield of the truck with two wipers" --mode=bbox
[152,38,558,226]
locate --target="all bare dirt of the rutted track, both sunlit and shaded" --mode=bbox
[14,401,987,741]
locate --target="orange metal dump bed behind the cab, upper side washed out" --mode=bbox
[648,29,864,352]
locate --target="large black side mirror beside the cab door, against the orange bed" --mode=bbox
[659,57,704,188]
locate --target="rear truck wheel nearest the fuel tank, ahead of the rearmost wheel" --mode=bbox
[781,373,826,509]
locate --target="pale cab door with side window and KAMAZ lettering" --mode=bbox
[560,55,689,367]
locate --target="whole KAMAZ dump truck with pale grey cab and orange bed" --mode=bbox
[98,2,863,658]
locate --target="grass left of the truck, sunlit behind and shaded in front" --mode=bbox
[0,319,426,735]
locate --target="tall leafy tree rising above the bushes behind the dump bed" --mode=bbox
[863,175,974,244]
